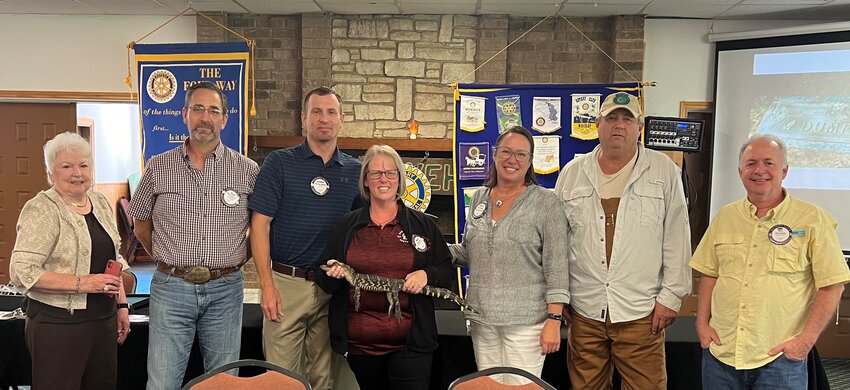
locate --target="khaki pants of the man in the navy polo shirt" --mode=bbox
[263,271,336,390]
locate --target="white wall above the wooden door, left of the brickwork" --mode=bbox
[0,14,197,92]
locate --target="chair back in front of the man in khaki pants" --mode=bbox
[183,359,312,390]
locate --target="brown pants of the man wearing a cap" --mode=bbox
[567,310,667,390]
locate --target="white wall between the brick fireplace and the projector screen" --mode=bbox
[644,19,827,117]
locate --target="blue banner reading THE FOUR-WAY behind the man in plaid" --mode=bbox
[134,42,249,161]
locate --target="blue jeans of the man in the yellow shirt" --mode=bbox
[702,349,809,390]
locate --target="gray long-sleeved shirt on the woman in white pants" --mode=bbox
[450,185,570,326]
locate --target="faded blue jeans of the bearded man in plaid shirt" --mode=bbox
[147,271,243,390]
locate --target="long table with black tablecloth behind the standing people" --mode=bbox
[0,297,829,390]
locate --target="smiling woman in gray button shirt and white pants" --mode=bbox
[450,126,569,384]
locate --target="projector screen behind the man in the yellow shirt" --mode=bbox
[710,32,850,250]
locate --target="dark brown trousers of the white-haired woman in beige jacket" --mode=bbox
[26,314,118,390]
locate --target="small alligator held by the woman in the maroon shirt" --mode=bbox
[319,261,475,321]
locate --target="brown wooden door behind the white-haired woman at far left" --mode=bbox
[0,103,77,283]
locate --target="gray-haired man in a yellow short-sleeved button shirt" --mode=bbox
[690,135,850,390]
